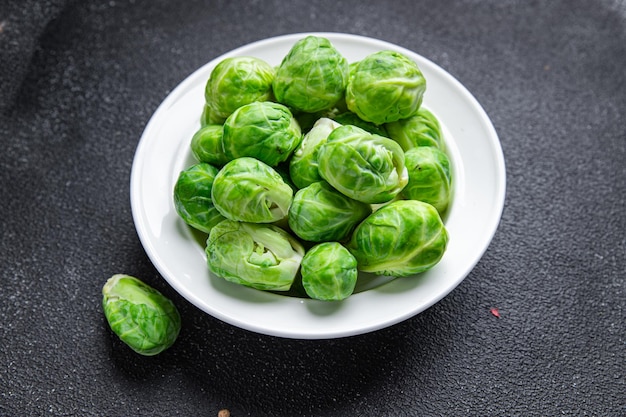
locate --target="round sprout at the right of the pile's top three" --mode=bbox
[346,51,426,125]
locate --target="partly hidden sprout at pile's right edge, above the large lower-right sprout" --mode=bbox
[402,146,452,215]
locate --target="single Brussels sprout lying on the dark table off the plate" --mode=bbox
[102,274,181,356]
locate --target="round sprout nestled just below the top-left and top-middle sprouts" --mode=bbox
[222,101,302,166]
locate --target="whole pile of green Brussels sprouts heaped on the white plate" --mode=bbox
[173,36,452,301]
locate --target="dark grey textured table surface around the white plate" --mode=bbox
[0,0,626,417]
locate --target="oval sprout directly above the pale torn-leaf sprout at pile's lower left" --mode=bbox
[211,157,293,223]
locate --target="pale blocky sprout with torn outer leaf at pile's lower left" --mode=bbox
[206,220,304,291]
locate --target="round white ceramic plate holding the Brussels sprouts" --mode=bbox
[130,33,505,339]
